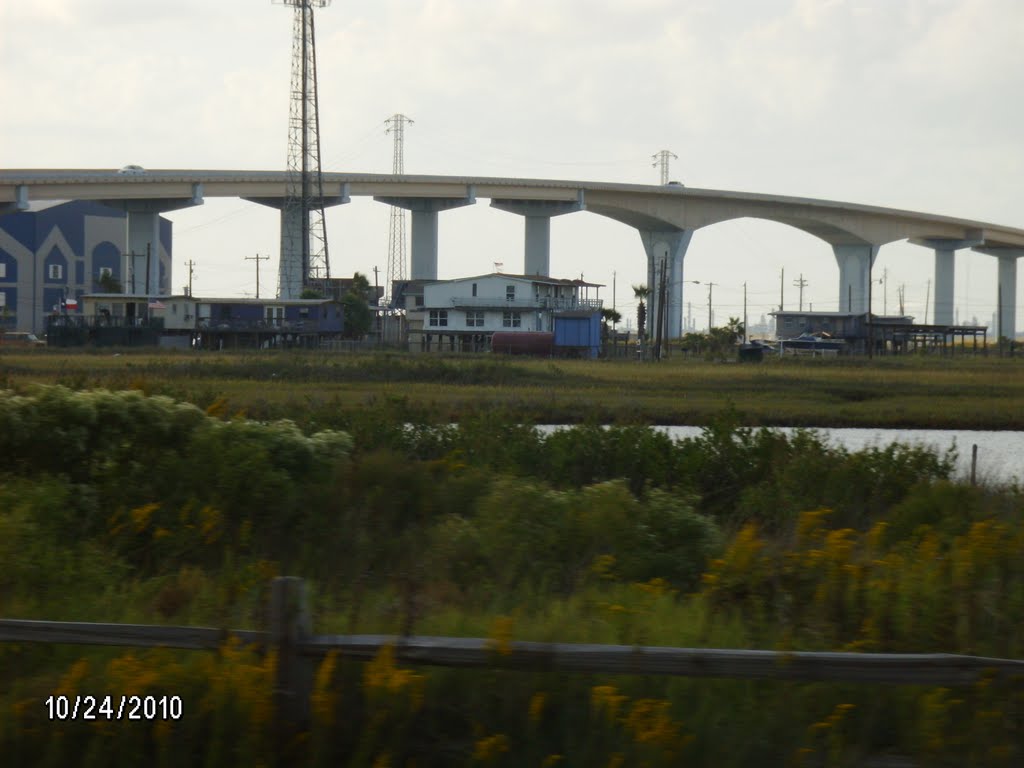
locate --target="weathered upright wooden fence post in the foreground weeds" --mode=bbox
[270,577,313,728]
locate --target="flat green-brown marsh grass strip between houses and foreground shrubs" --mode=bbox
[0,350,1024,429]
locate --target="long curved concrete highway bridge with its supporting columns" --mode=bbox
[0,170,1024,336]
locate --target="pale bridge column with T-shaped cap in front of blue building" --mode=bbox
[102,183,203,296]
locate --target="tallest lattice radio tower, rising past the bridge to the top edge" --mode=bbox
[273,0,331,299]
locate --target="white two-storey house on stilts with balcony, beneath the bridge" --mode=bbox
[402,272,602,351]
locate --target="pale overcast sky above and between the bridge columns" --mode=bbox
[0,0,1024,328]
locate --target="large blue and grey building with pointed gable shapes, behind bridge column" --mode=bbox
[0,201,171,334]
